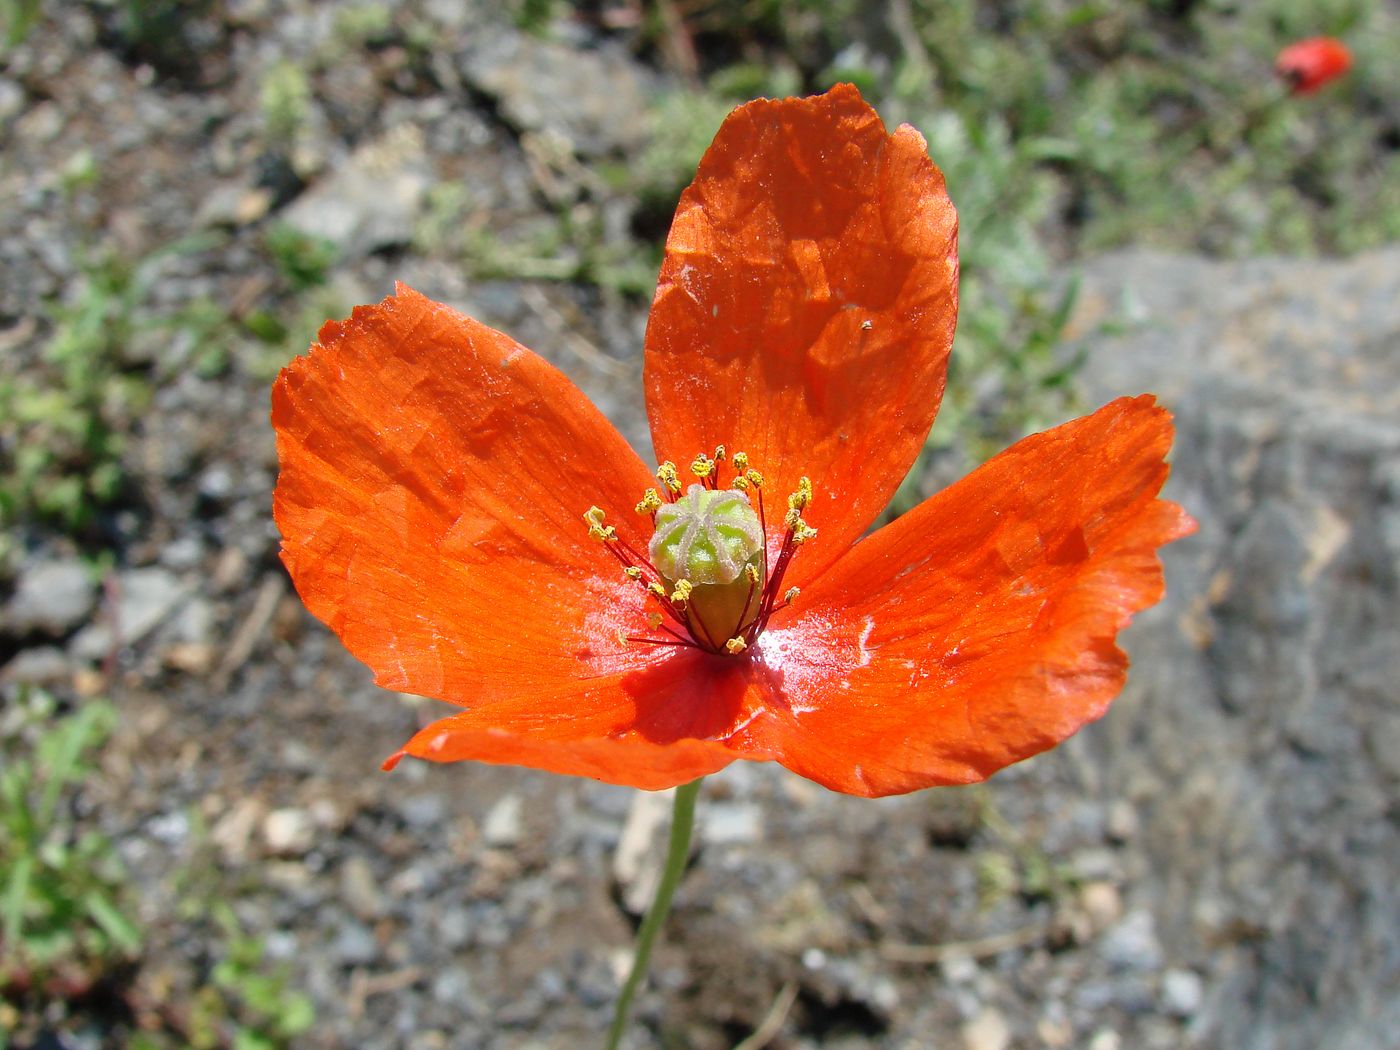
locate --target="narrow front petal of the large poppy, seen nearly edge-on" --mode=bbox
[384,711,739,791]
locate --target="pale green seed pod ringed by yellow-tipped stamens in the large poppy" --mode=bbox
[584,445,816,657]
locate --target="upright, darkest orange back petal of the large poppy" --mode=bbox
[645,84,958,584]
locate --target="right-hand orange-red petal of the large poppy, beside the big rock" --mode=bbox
[731,396,1194,795]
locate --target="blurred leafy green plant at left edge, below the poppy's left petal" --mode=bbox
[0,693,141,997]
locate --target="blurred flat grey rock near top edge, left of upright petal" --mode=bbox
[461,32,651,155]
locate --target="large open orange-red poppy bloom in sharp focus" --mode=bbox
[272,85,1193,795]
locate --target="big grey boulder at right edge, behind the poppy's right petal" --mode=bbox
[1057,248,1400,1050]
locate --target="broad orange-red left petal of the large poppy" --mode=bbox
[272,286,669,718]
